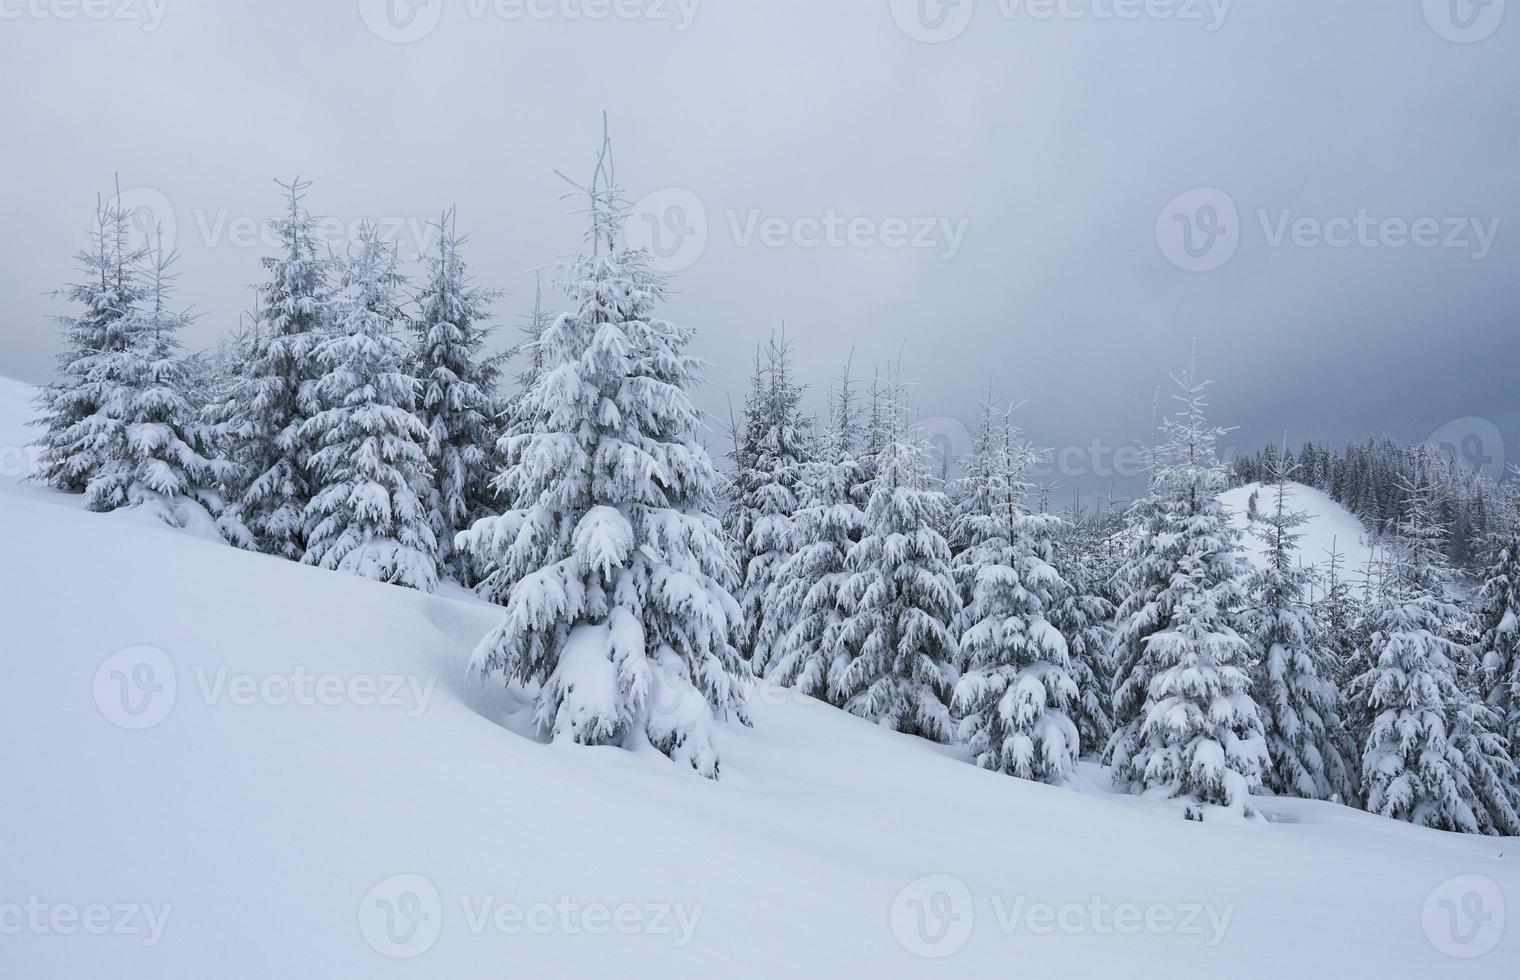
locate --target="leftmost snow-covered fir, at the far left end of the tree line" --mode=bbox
[35,186,144,498]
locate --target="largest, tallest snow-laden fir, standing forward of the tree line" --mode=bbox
[459,126,748,778]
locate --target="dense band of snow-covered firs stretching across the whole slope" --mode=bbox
[26,147,1520,834]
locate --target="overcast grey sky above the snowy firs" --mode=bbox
[0,0,1520,498]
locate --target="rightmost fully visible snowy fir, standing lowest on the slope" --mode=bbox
[1351,479,1491,833]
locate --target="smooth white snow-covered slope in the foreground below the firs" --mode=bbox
[0,372,1520,980]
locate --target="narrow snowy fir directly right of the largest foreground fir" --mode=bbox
[736,336,809,676]
